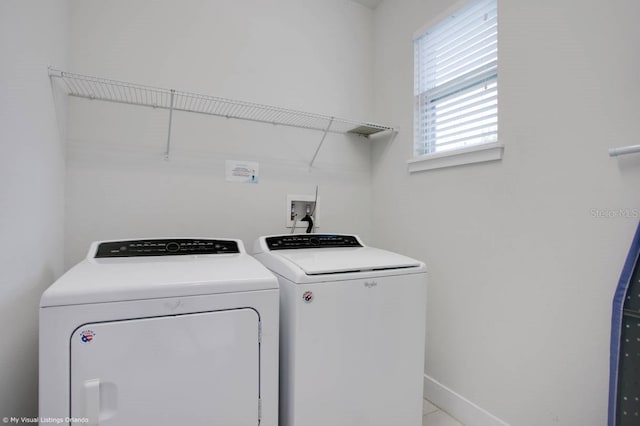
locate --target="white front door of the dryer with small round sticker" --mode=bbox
[70,309,260,426]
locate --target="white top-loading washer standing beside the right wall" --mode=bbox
[254,234,427,426]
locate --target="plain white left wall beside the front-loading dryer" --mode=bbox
[0,0,68,417]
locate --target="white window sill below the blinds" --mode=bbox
[407,142,504,173]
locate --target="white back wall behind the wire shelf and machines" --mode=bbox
[65,0,373,267]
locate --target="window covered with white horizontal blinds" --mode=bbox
[414,0,502,162]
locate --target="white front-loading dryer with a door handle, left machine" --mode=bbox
[39,239,278,426]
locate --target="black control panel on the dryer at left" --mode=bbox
[95,238,240,258]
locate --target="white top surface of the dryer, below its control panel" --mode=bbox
[40,240,278,307]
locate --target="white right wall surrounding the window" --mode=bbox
[372,0,640,426]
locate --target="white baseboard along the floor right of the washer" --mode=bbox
[424,374,509,426]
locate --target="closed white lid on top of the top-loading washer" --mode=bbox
[272,247,423,275]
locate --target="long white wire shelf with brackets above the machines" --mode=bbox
[49,68,396,165]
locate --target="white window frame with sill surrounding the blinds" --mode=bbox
[407,0,504,173]
